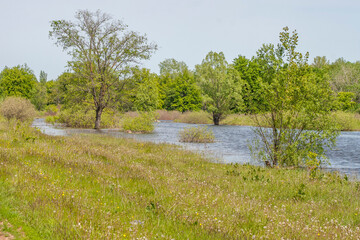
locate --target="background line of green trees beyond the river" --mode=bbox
[0,45,360,124]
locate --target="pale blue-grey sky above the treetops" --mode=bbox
[0,0,360,80]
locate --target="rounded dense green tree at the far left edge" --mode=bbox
[0,64,37,99]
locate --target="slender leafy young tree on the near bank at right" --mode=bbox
[250,27,337,166]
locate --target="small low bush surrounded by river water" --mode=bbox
[179,127,215,143]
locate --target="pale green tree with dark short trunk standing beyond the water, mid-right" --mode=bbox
[195,52,242,125]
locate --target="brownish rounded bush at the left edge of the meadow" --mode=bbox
[0,97,36,122]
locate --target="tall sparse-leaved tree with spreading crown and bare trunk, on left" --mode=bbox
[49,10,157,129]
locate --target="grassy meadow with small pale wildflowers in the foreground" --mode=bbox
[0,122,360,239]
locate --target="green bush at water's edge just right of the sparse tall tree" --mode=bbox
[122,112,156,133]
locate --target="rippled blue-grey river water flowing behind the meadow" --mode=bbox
[33,119,360,176]
